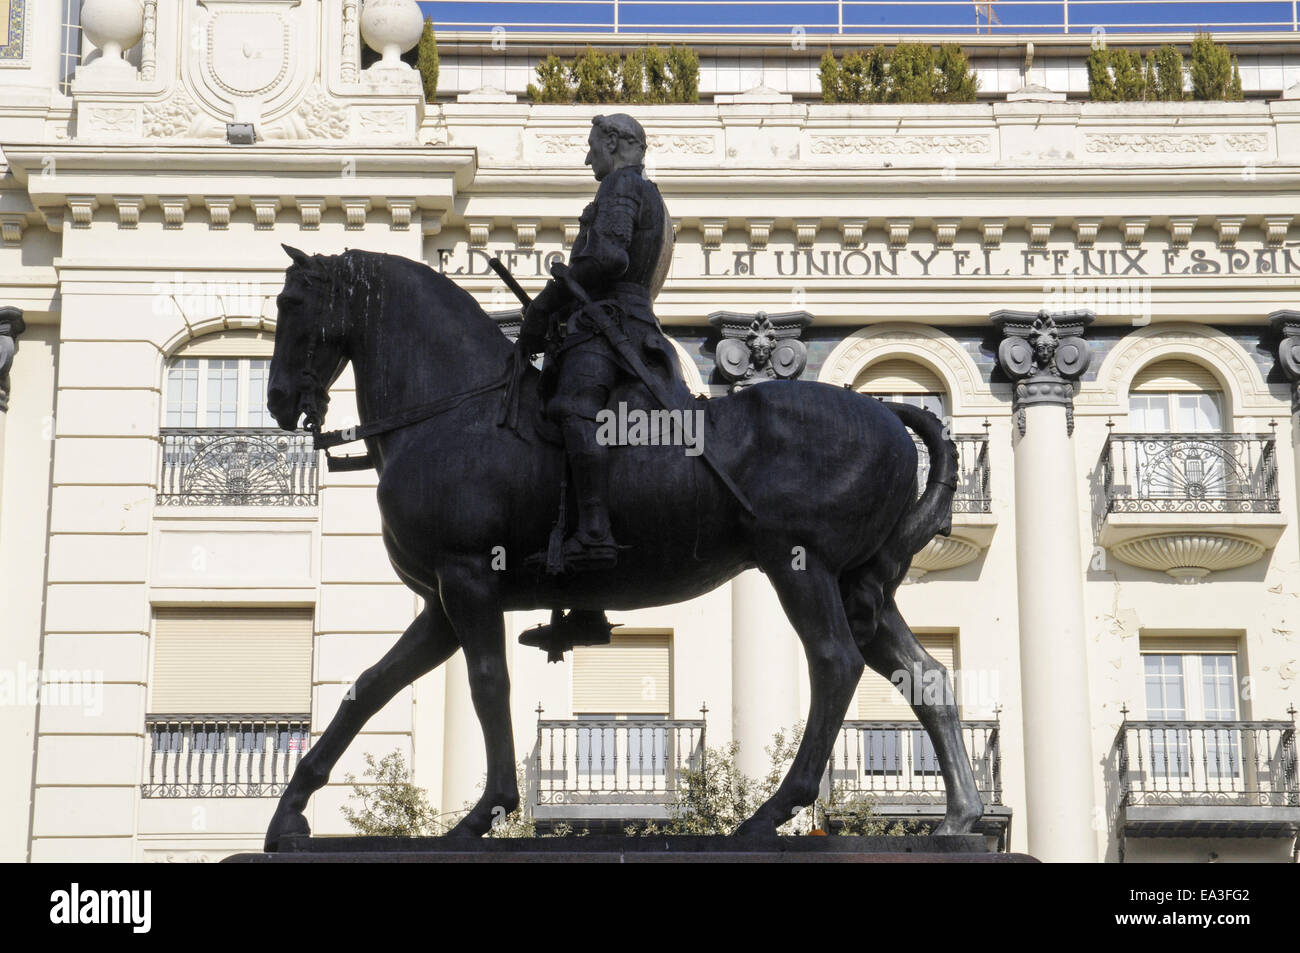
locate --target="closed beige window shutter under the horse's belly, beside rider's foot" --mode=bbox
[573,632,672,715]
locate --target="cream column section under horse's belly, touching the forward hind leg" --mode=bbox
[732,569,803,777]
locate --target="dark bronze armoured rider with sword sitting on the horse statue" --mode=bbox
[519,113,690,571]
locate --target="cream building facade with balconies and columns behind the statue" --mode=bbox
[0,0,1300,862]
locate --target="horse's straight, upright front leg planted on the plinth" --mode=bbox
[439,568,519,837]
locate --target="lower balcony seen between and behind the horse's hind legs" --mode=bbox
[827,719,1011,850]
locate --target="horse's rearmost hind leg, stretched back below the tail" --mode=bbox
[849,597,984,833]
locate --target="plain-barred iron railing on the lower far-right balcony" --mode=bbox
[1115,720,1300,807]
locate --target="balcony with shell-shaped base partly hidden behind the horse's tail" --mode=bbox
[907,433,997,582]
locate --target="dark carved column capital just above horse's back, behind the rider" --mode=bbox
[709,311,813,391]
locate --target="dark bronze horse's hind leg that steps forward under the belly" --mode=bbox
[736,556,863,836]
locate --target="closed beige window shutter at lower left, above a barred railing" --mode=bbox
[150,608,312,715]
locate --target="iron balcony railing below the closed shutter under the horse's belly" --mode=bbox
[532,716,705,807]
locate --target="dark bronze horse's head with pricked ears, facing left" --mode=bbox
[267,244,348,430]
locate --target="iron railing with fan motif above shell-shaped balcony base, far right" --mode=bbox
[1101,433,1279,514]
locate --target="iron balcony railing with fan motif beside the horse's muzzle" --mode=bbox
[157,426,317,506]
